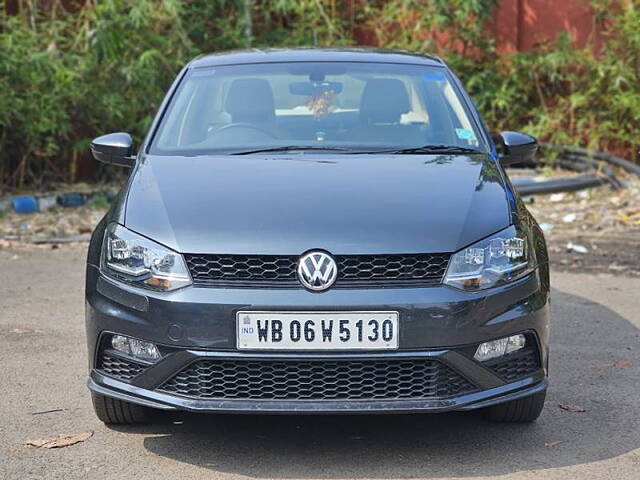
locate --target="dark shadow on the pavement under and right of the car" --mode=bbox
[112,291,640,478]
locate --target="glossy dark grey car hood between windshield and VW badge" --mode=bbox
[123,153,510,255]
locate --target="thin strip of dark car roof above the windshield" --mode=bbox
[189,48,445,68]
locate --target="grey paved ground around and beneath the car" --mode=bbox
[0,248,640,480]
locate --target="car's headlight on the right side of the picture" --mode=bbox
[444,226,535,290]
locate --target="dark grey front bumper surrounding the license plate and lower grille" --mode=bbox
[86,265,548,413]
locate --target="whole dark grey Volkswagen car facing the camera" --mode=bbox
[86,49,549,424]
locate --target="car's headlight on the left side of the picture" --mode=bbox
[102,223,191,292]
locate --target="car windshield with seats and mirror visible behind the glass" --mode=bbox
[149,62,484,155]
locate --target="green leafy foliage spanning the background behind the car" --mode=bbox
[0,0,640,187]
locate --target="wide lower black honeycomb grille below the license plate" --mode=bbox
[160,359,475,400]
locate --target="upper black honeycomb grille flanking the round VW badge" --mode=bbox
[185,253,450,287]
